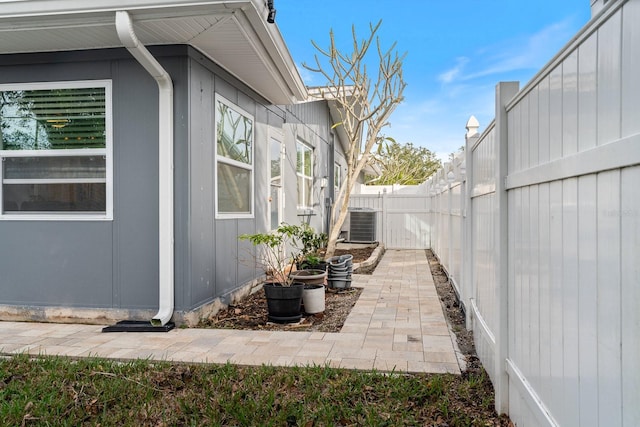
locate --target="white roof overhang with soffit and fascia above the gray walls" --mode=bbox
[0,0,307,104]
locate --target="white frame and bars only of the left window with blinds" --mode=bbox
[0,80,113,221]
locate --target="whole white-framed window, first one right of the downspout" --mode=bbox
[215,95,253,218]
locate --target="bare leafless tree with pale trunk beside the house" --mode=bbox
[303,21,406,257]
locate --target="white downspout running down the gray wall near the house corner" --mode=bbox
[116,11,174,326]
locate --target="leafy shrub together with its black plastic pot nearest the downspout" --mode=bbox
[239,223,304,323]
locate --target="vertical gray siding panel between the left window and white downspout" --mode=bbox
[114,57,158,308]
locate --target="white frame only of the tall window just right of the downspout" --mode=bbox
[213,93,256,219]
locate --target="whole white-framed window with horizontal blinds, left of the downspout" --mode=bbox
[0,80,113,219]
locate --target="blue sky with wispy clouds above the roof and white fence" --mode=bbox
[274,0,591,159]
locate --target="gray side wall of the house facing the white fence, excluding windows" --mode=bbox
[176,60,340,316]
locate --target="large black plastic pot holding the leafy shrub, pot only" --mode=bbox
[263,283,304,323]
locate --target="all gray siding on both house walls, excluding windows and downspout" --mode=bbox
[0,46,342,324]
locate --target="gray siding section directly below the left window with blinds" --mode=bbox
[0,221,115,307]
